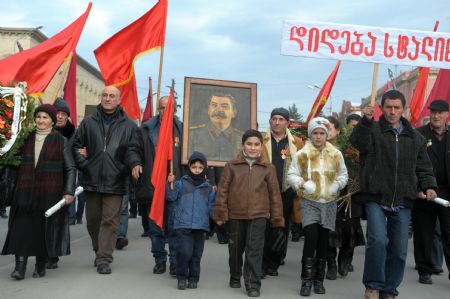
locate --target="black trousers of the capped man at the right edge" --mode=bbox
[412,189,450,274]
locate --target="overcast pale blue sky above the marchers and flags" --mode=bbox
[0,0,450,129]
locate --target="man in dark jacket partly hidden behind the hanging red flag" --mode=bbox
[130,97,183,276]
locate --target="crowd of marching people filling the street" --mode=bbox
[0,86,450,299]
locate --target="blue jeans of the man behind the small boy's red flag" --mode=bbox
[148,201,177,263]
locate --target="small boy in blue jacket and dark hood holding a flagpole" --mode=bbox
[166,152,215,290]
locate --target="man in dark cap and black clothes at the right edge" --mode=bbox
[412,100,450,284]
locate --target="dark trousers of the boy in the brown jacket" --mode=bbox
[228,218,267,290]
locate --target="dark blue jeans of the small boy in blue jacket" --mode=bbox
[175,229,205,282]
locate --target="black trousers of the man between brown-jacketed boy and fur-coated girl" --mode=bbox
[263,189,295,270]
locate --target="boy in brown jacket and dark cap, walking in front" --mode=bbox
[214,130,284,297]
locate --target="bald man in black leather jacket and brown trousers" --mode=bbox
[73,86,137,274]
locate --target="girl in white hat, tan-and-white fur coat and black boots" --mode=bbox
[288,117,348,296]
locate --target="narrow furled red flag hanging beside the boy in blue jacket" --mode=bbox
[149,88,173,228]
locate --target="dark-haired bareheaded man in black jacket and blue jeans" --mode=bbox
[350,90,437,298]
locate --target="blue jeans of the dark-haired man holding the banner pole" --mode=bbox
[363,202,411,296]
